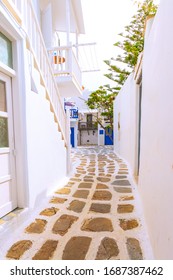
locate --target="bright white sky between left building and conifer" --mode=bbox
[81,0,159,91]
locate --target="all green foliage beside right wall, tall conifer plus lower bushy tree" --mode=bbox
[86,0,157,136]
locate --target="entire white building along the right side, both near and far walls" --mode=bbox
[114,0,173,259]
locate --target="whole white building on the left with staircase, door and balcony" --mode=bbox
[0,0,84,217]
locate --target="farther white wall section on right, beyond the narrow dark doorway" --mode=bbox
[114,74,138,174]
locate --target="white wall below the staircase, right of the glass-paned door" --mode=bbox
[26,51,67,207]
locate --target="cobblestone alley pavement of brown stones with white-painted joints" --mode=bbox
[0,147,152,260]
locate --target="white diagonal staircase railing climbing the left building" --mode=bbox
[3,0,69,147]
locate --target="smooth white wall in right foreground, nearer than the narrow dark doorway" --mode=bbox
[139,0,173,259]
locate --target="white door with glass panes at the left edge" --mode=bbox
[0,72,17,217]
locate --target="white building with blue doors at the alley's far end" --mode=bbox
[69,89,113,147]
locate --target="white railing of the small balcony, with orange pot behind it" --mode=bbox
[48,46,82,87]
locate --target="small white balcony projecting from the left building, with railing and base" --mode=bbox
[48,46,82,97]
